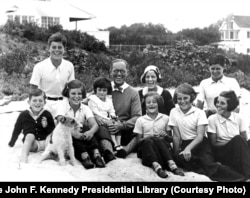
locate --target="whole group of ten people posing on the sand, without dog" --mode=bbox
[9,33,250,181]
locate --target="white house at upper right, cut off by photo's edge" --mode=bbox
[218,15,250,55]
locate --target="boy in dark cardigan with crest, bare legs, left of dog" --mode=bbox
[9,89,55,163]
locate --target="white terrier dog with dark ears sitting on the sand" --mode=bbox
[41,116,80,166]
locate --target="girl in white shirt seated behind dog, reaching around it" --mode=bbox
[56,80,105,169]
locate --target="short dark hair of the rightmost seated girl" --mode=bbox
[214,91,239,111]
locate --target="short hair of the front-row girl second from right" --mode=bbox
[173,83,197,104]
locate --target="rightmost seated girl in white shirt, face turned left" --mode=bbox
[207,91,250,179]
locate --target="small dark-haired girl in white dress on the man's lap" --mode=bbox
[88,77,123,154]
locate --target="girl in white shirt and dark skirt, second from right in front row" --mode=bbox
[169,83,245,181]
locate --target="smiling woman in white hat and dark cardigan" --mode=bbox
[139,65,175,115]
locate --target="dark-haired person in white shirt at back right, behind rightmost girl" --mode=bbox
[197,54,240,117]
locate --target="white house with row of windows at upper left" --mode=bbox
[0,0,109,46]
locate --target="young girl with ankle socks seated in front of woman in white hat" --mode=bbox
[134,92,184,178]
